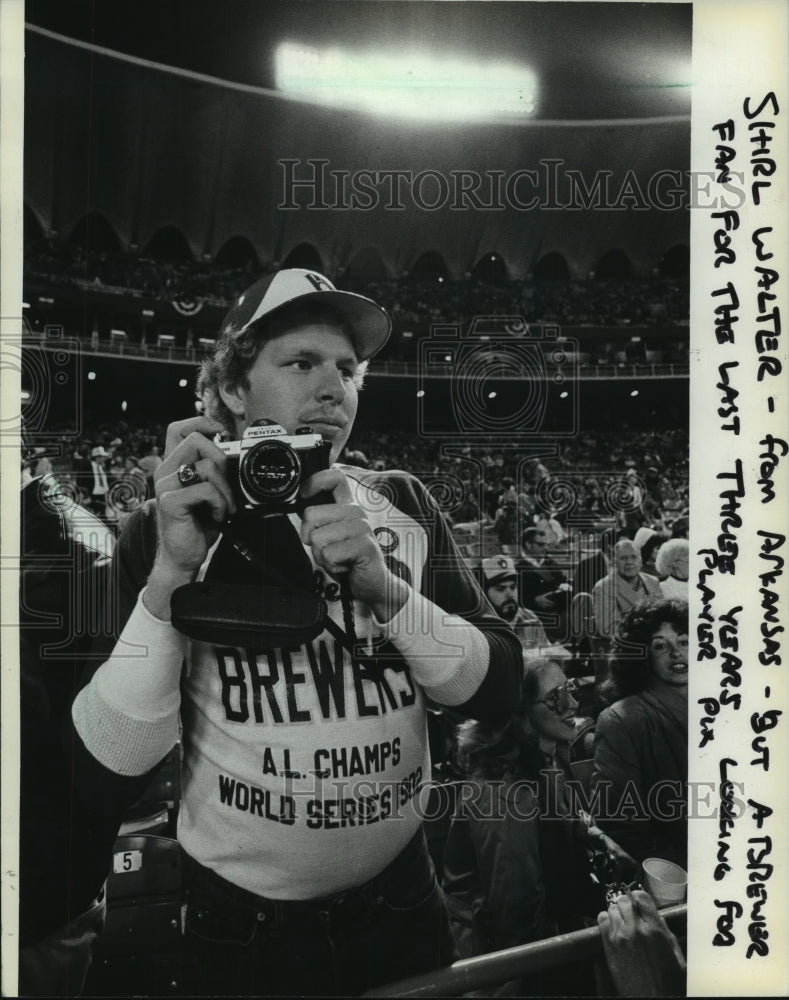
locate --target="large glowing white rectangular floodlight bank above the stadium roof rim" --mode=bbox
[274,42,537,121]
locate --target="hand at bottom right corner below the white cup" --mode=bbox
[597,889,686,997]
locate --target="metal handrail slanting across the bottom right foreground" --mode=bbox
[363,903,688,997]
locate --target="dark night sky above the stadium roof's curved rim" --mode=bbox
[24,0,692,119]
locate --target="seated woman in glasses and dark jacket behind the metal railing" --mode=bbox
[443,656,638,996]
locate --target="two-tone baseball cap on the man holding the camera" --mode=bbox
[220,267,392,361]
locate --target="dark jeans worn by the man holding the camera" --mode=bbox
[184,830,457,996]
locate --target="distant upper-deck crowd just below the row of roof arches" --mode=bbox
[25,238,689,333]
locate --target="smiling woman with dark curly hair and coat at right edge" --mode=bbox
[592,599,688,868]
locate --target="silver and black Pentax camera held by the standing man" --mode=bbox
[216,418,333,514]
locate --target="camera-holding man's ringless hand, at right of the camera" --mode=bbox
[301,469,408,622]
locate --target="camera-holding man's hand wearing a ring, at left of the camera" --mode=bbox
[145,417,236,620]
